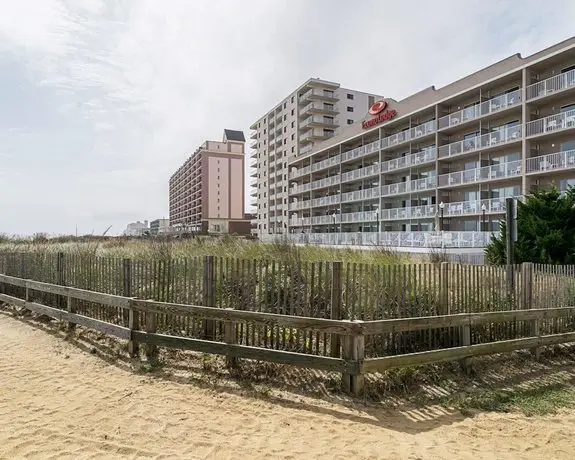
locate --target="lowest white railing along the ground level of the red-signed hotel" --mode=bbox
[289,232,491,248]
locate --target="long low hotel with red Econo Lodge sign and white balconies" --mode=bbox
[288,38,575,248]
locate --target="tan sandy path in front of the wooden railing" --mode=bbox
[0,313,575,460]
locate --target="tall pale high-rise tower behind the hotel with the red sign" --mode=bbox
[250,78,381,240]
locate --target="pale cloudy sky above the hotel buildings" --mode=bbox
[0,0,575,235]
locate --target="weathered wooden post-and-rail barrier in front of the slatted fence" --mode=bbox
[0,274,575,394]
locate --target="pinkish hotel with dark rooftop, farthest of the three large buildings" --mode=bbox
[170,129,251,235]
